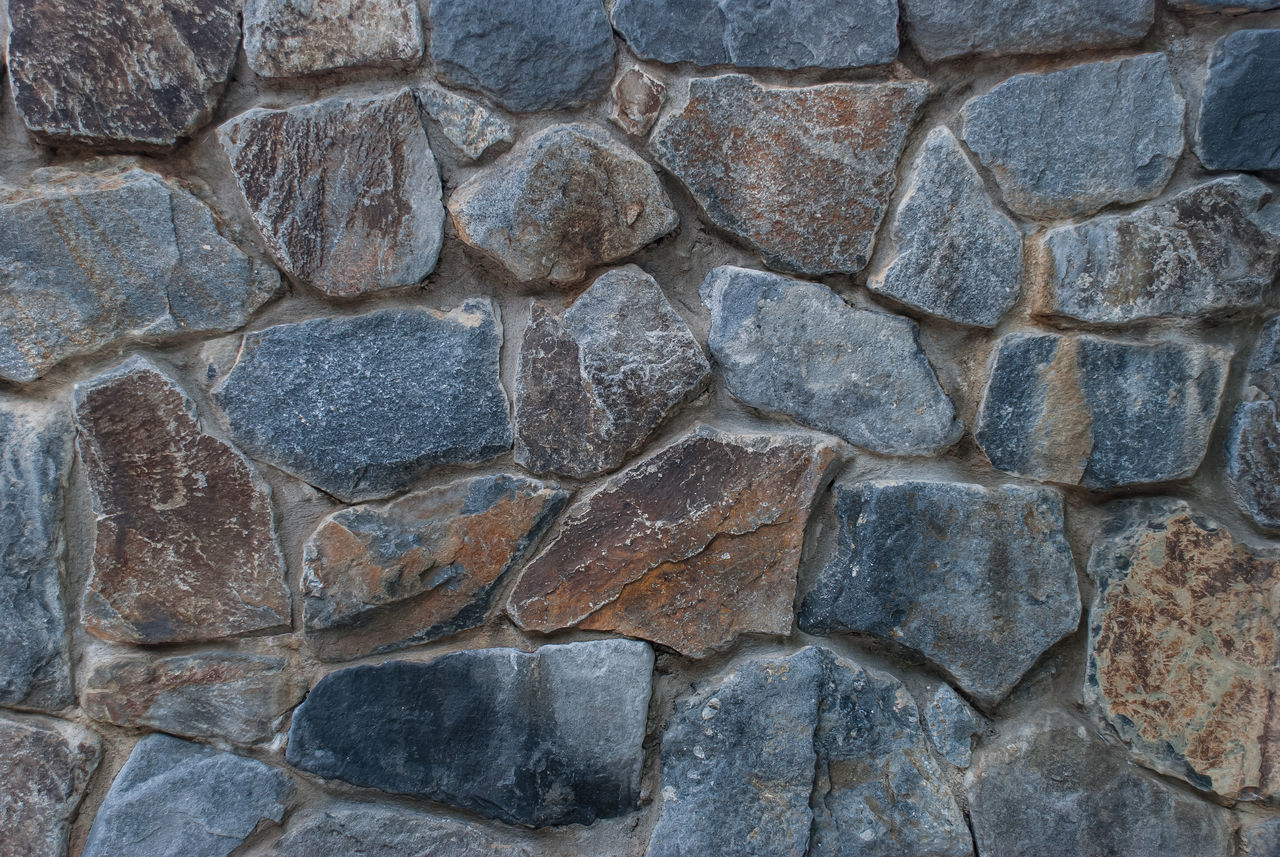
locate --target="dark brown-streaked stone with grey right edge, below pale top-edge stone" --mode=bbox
[225,90,444,297]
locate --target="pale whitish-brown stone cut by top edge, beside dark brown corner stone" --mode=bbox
[244,0,425,77]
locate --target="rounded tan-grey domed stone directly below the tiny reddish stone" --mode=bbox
[448,124,680,283]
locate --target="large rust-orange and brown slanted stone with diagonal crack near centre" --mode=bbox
[507,426,837,657]
